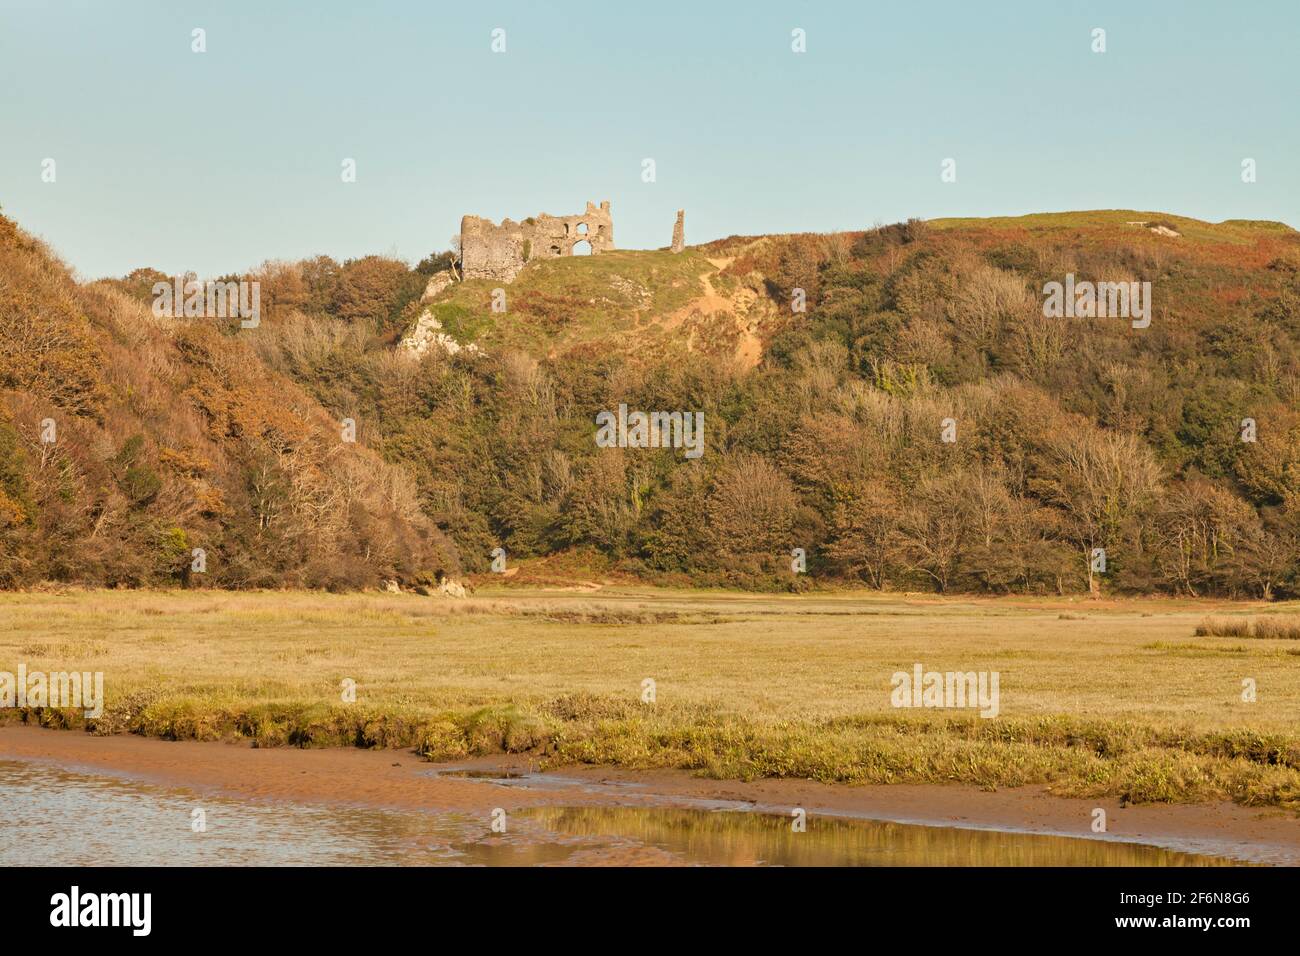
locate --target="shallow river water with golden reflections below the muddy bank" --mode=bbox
[0,761,1230,866]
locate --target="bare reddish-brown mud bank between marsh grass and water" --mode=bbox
[0,724,1300,865]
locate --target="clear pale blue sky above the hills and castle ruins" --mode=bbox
[0,0,1300,277]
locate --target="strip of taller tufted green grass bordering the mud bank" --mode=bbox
[17,695,1300,810]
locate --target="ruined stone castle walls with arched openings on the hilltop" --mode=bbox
[460,199,614,282]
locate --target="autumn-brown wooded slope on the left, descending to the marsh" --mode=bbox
[0,217,459,589]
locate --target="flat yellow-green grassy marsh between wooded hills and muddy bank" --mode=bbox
[0,588,1300,809]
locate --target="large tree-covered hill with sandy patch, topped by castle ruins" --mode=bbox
[9,209,1300,597]
